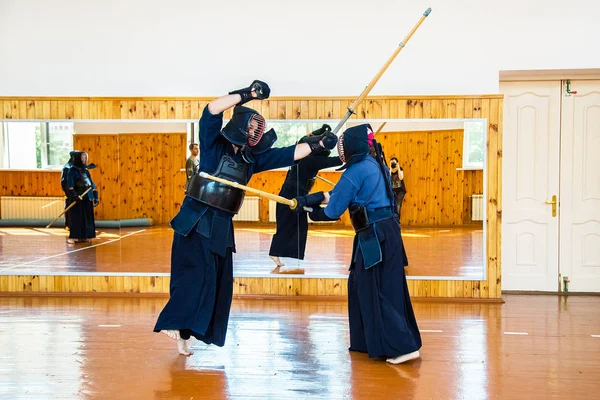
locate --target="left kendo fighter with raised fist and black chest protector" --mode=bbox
[154,81,337,355]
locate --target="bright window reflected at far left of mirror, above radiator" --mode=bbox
[0,122,73,169]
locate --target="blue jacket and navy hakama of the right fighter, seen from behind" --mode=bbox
[322,155,421,357]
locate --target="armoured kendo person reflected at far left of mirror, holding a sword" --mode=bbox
[67,151,99,243]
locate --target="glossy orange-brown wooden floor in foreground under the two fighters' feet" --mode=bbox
[0,295,600,400]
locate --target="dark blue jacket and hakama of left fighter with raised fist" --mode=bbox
[154,107,296,346]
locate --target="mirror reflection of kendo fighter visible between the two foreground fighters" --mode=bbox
[269,124,342,274]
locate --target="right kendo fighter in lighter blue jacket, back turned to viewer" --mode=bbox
[296,124,421,364]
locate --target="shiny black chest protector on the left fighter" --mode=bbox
[185,155,248,214]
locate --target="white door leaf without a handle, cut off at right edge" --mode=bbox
[560,81,600,292]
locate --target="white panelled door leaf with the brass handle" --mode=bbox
[500,81,564,292]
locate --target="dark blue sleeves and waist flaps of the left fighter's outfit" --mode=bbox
[171,106,296,257]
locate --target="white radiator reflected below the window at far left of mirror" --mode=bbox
[0,196,65,219]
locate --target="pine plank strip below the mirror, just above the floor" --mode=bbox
[0,275,502,302]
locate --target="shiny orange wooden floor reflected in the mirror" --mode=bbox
[0,224,484,280]
